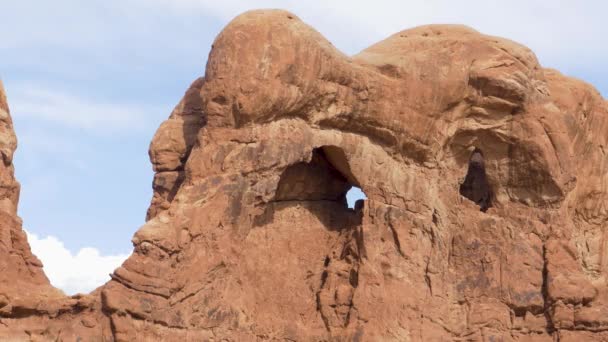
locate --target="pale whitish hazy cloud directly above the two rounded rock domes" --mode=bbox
[153,0,608,70]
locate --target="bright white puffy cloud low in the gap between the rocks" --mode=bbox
[26,231,129,295]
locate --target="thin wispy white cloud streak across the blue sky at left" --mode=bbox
[9,82,158,132]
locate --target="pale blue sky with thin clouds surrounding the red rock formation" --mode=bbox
[0,0,608,292]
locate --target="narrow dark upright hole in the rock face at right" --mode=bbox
[460,147,492,212]
